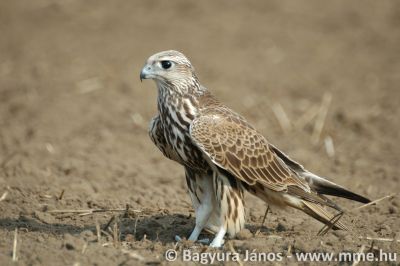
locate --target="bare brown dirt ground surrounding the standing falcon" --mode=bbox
[0,0,400,265]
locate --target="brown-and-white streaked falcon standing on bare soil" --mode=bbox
[140,50,370,247]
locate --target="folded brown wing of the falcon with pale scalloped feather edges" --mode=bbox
[190,113,310,192]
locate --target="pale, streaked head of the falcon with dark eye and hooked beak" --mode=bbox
[140,50,198,92]
